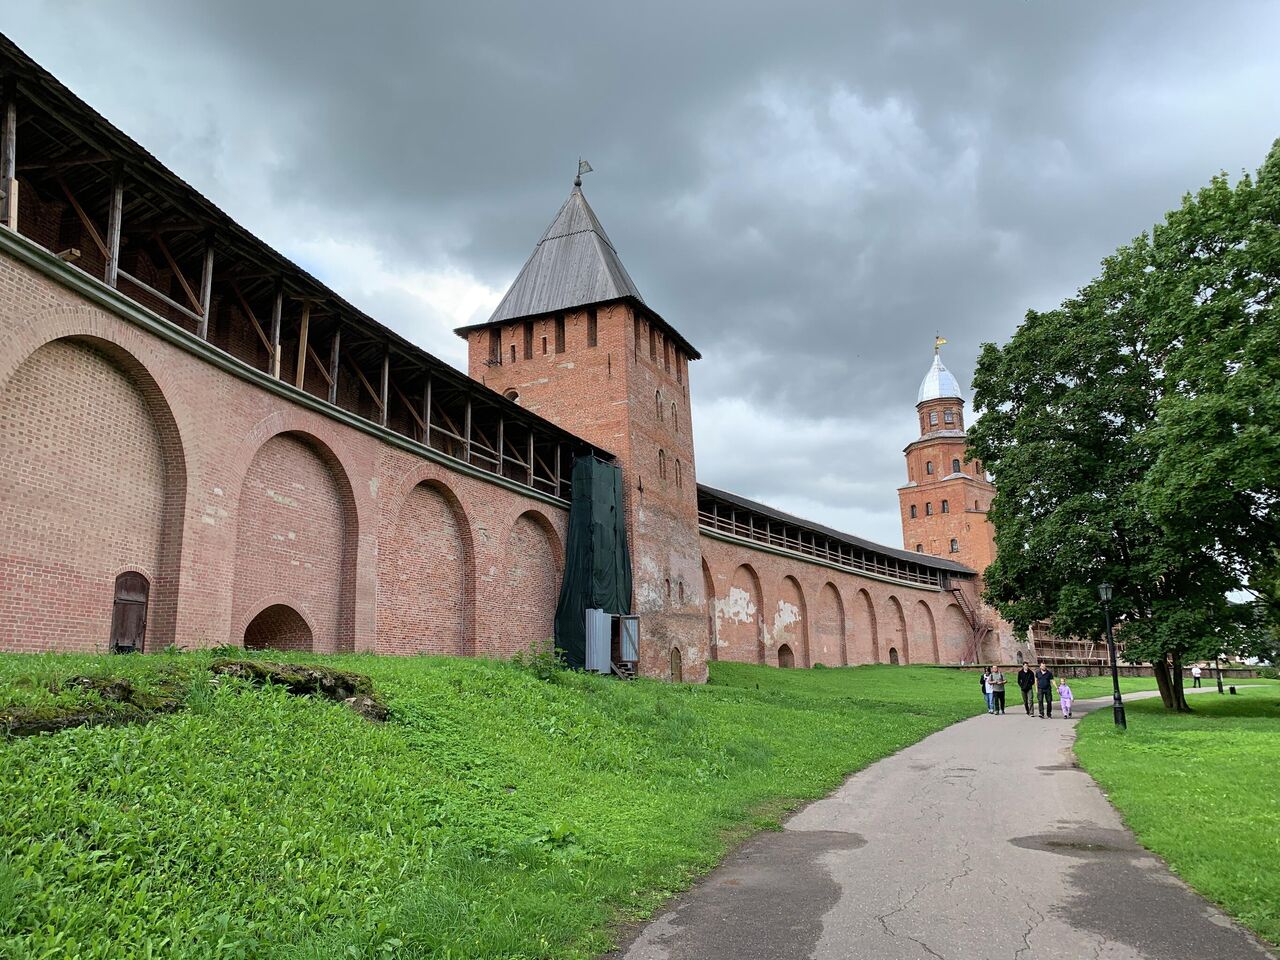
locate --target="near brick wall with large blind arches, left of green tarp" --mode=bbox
[0,257,566,654]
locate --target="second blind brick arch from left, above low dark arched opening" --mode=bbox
[232,432,360,653]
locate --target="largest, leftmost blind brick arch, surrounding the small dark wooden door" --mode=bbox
[0,332,187,652]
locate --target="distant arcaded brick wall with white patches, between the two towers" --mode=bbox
[701,536,977,666]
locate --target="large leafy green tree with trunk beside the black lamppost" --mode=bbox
[969,145,1280,710]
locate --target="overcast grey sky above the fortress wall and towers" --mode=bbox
[0,0,1280,545]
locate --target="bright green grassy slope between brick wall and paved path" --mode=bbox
[0,654,980,957]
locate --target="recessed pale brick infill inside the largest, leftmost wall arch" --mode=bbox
[0,340,166,652]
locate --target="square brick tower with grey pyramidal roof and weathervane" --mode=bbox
[458,178,708,681]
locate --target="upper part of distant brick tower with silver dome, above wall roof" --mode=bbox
[897,346,996,573]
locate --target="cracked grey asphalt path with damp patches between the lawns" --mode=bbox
[612,687,1275,960]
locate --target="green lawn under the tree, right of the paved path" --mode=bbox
[1075,681,1280,943]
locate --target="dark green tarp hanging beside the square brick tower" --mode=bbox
[556,457,631,669]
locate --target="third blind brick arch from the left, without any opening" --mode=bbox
[378,476,475,655]
